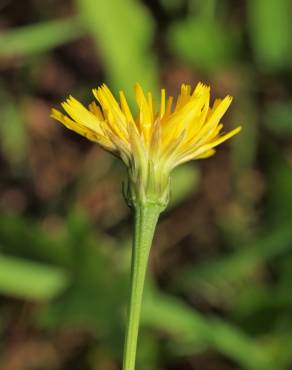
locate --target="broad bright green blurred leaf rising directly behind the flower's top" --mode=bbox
[77,0,158,99]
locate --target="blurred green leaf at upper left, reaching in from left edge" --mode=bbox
[0,18,84,57]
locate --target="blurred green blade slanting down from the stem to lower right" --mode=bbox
[142,292,275,370]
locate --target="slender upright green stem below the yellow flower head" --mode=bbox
[123,204,162,370]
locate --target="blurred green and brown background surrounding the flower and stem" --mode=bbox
[0,0,292,370]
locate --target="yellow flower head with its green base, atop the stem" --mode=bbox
[51,83,241,206]
